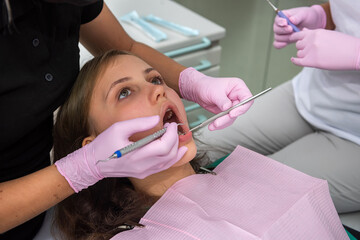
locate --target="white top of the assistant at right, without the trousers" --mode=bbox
[293,0,360,145]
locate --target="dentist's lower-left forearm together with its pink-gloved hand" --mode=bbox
[0,116,187,233]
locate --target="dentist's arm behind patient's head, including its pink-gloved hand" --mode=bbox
[80,4,252,130]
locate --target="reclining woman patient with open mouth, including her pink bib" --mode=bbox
[54,50,346,239]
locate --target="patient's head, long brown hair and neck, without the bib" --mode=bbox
[54,51,196,239]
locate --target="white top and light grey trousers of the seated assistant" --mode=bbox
[195,0,360,213]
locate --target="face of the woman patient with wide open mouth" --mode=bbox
[89,55,196,166]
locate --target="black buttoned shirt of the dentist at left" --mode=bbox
[0,0,103,240]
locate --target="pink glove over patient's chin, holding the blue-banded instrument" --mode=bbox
[55,116,187,192]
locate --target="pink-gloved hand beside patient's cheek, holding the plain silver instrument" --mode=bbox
[179,68,253,131]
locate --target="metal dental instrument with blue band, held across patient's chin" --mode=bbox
[96,123,183,164]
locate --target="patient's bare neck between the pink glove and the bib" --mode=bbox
[130,163,195,197]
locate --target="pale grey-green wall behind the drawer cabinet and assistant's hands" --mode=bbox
[176,0,326,93]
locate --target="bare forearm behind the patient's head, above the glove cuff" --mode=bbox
[80,3,186,94]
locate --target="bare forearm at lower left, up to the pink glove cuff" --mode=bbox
[0,165,74,233]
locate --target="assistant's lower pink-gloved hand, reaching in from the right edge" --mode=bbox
[290,29,360,70]
